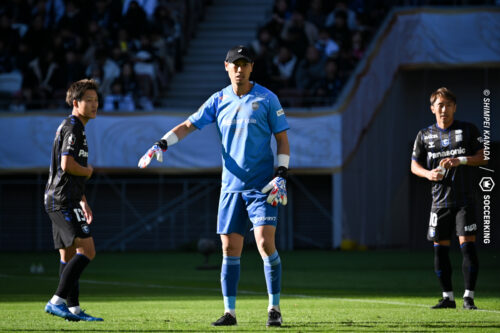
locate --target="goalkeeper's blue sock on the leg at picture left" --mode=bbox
[220,256,240,312]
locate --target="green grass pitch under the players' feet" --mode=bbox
[0,249,500,332]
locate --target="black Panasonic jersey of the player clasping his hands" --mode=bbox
[412,120,482,208]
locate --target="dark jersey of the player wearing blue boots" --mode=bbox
[44,115,89,212]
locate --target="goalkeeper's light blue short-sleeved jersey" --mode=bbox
[189,83,289,192]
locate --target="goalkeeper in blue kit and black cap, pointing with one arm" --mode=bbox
[139,46,290,326]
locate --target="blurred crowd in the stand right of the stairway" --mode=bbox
[250,0,388,107]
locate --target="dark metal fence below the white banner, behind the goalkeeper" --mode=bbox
[0,173,332,251]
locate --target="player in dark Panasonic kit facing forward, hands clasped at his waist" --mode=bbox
[411,88,486,309]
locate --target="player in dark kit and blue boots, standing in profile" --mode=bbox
[44,80,102,321]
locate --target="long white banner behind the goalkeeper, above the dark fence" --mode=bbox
[0,113,341,169]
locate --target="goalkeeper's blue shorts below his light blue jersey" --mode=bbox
[217,190,278,236]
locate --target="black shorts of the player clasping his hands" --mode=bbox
[427,206,477,242]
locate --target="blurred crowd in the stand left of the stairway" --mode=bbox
[0,0,206,111]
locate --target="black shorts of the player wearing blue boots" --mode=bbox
[48,208,92,249]
